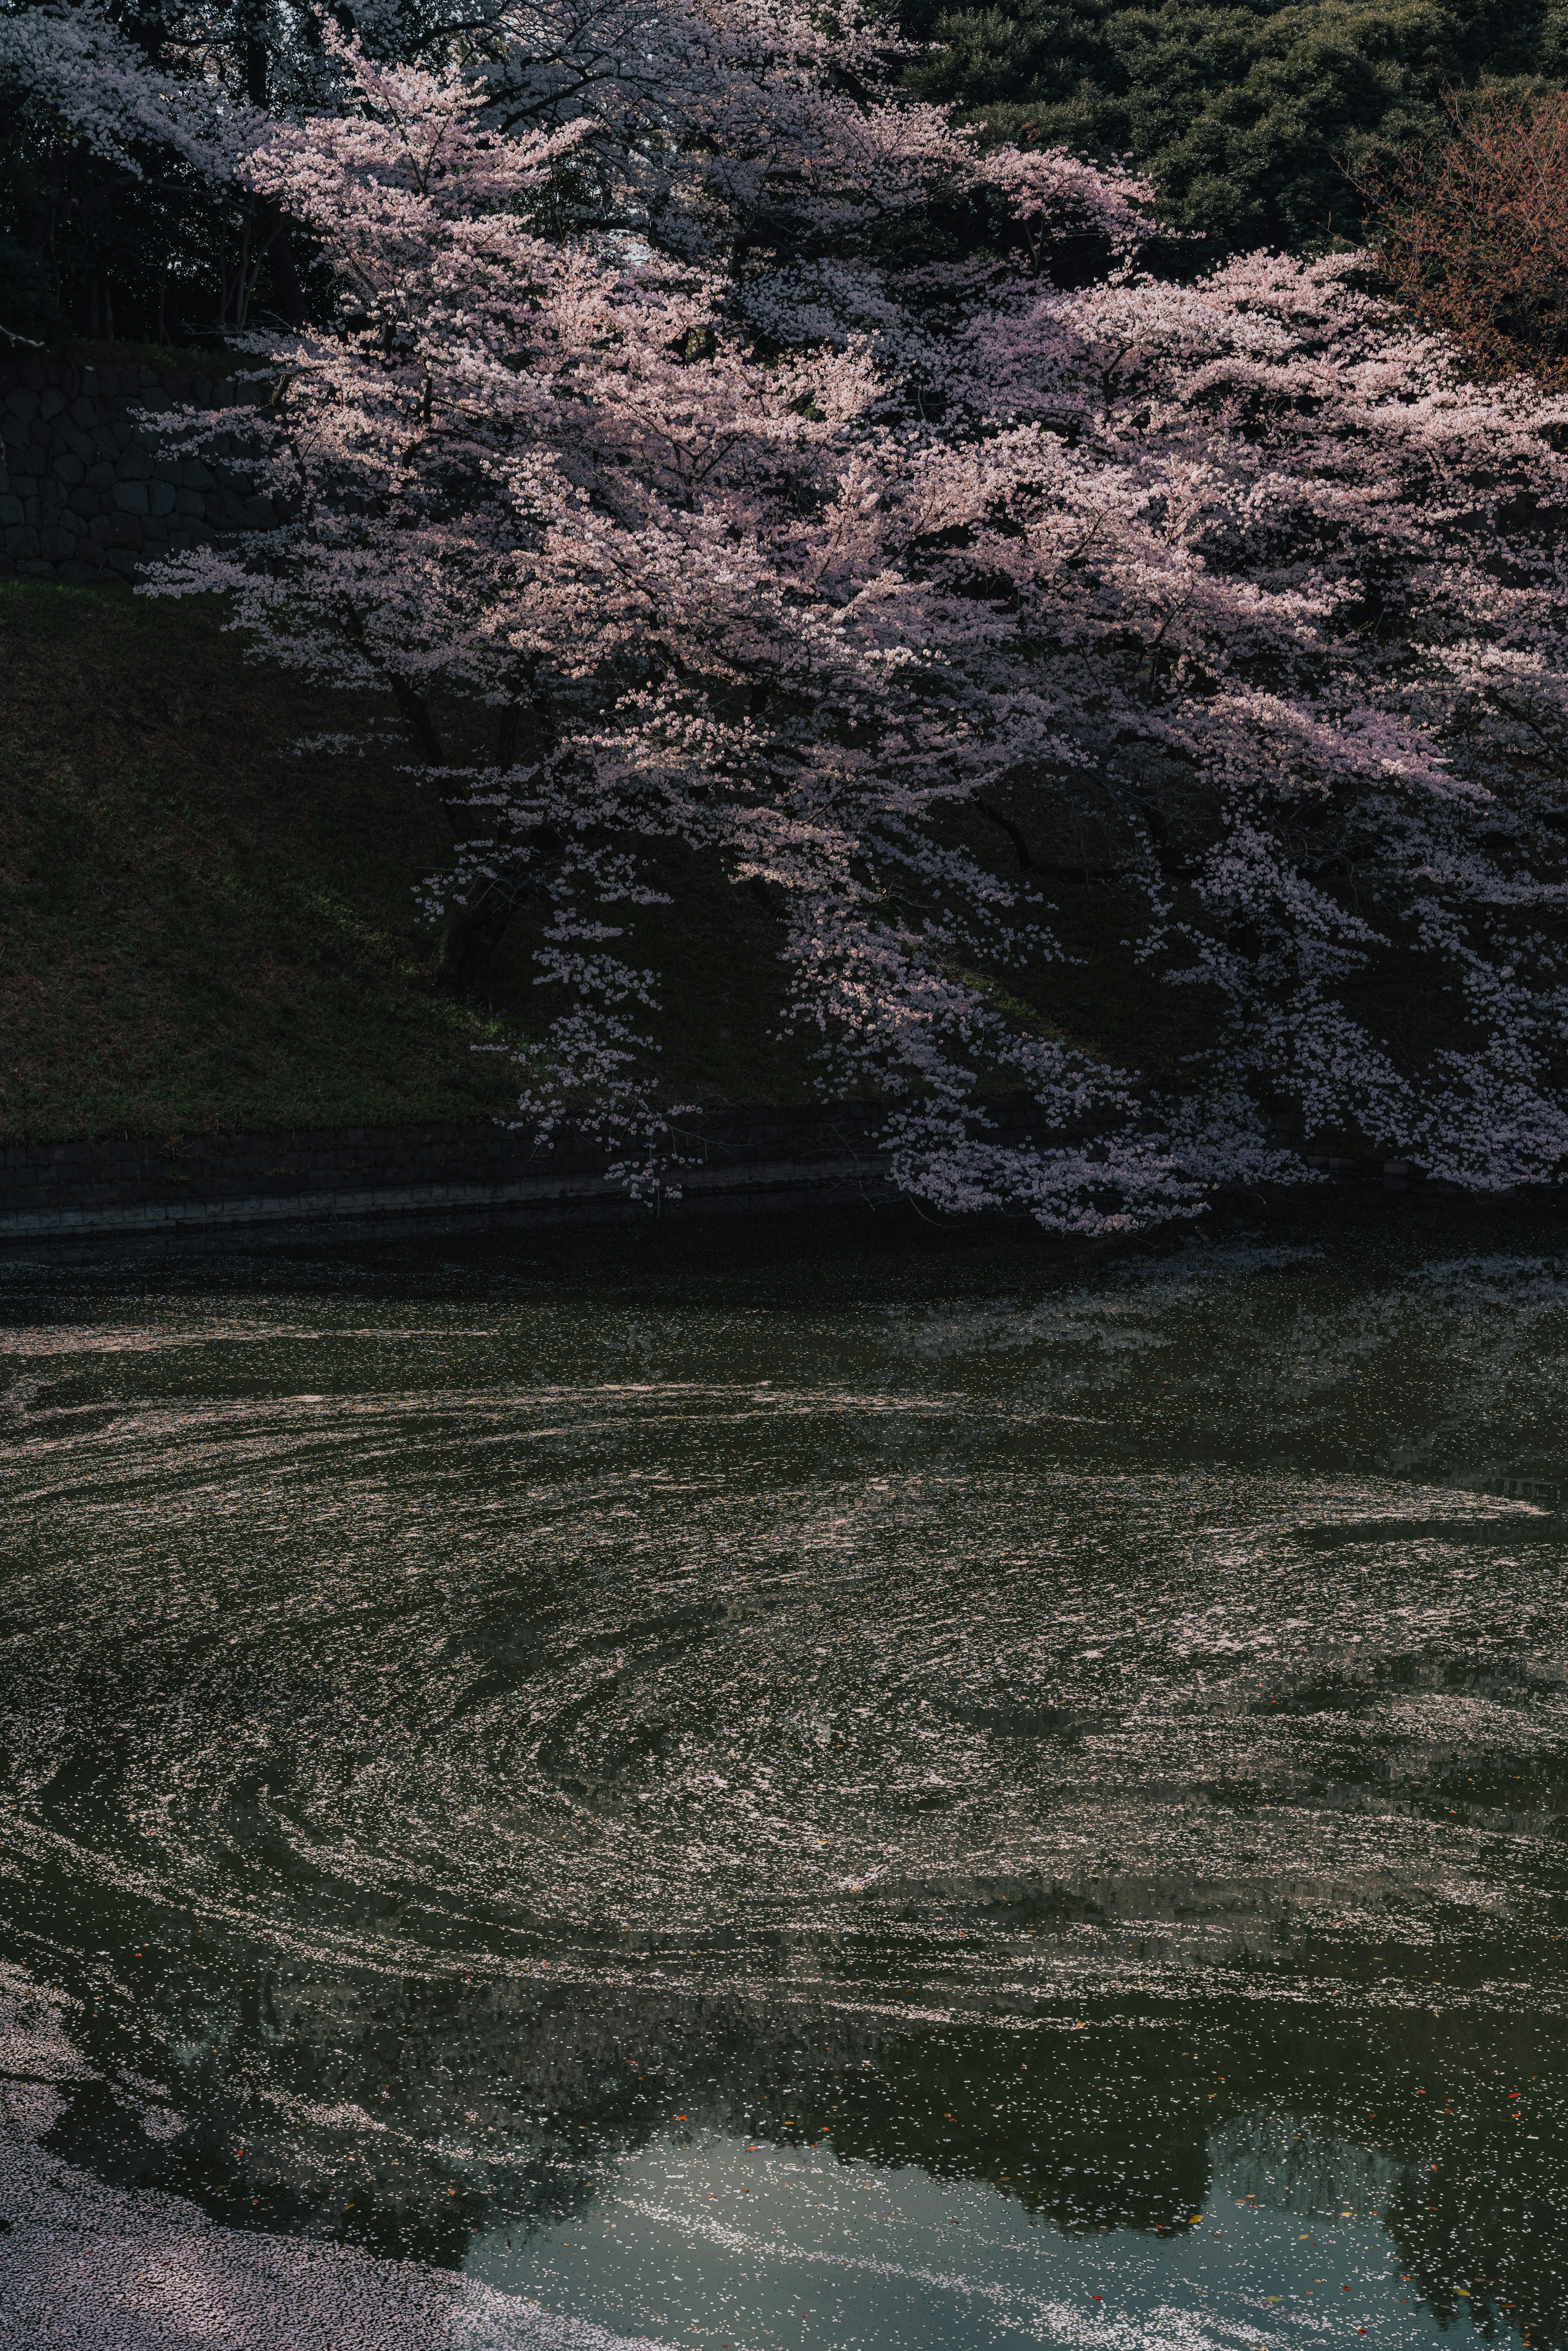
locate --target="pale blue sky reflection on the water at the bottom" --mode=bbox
[454,2116,1512,2351]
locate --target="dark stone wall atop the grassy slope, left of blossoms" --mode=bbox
[0,357,275,583]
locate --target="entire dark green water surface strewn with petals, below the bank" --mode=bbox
[0,1227,1568,2351]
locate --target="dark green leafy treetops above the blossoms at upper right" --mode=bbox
[903,0,1568,258]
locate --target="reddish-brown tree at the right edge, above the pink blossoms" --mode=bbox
[1359,92,1568,386]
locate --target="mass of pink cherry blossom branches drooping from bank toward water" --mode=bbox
[135,32,1568,1230]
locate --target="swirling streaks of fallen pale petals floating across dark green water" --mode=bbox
[0,1243,1568,2342]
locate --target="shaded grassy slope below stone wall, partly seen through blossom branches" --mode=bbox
[0,581,1194,1140]
